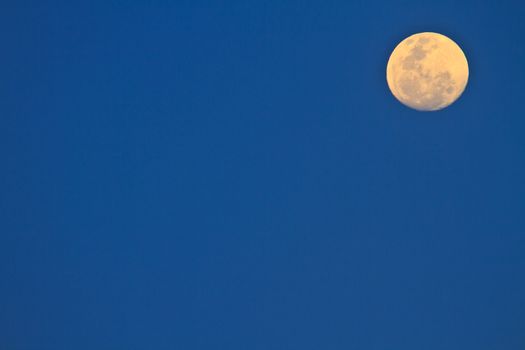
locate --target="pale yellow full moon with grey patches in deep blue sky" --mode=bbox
[386,32,469,111]
